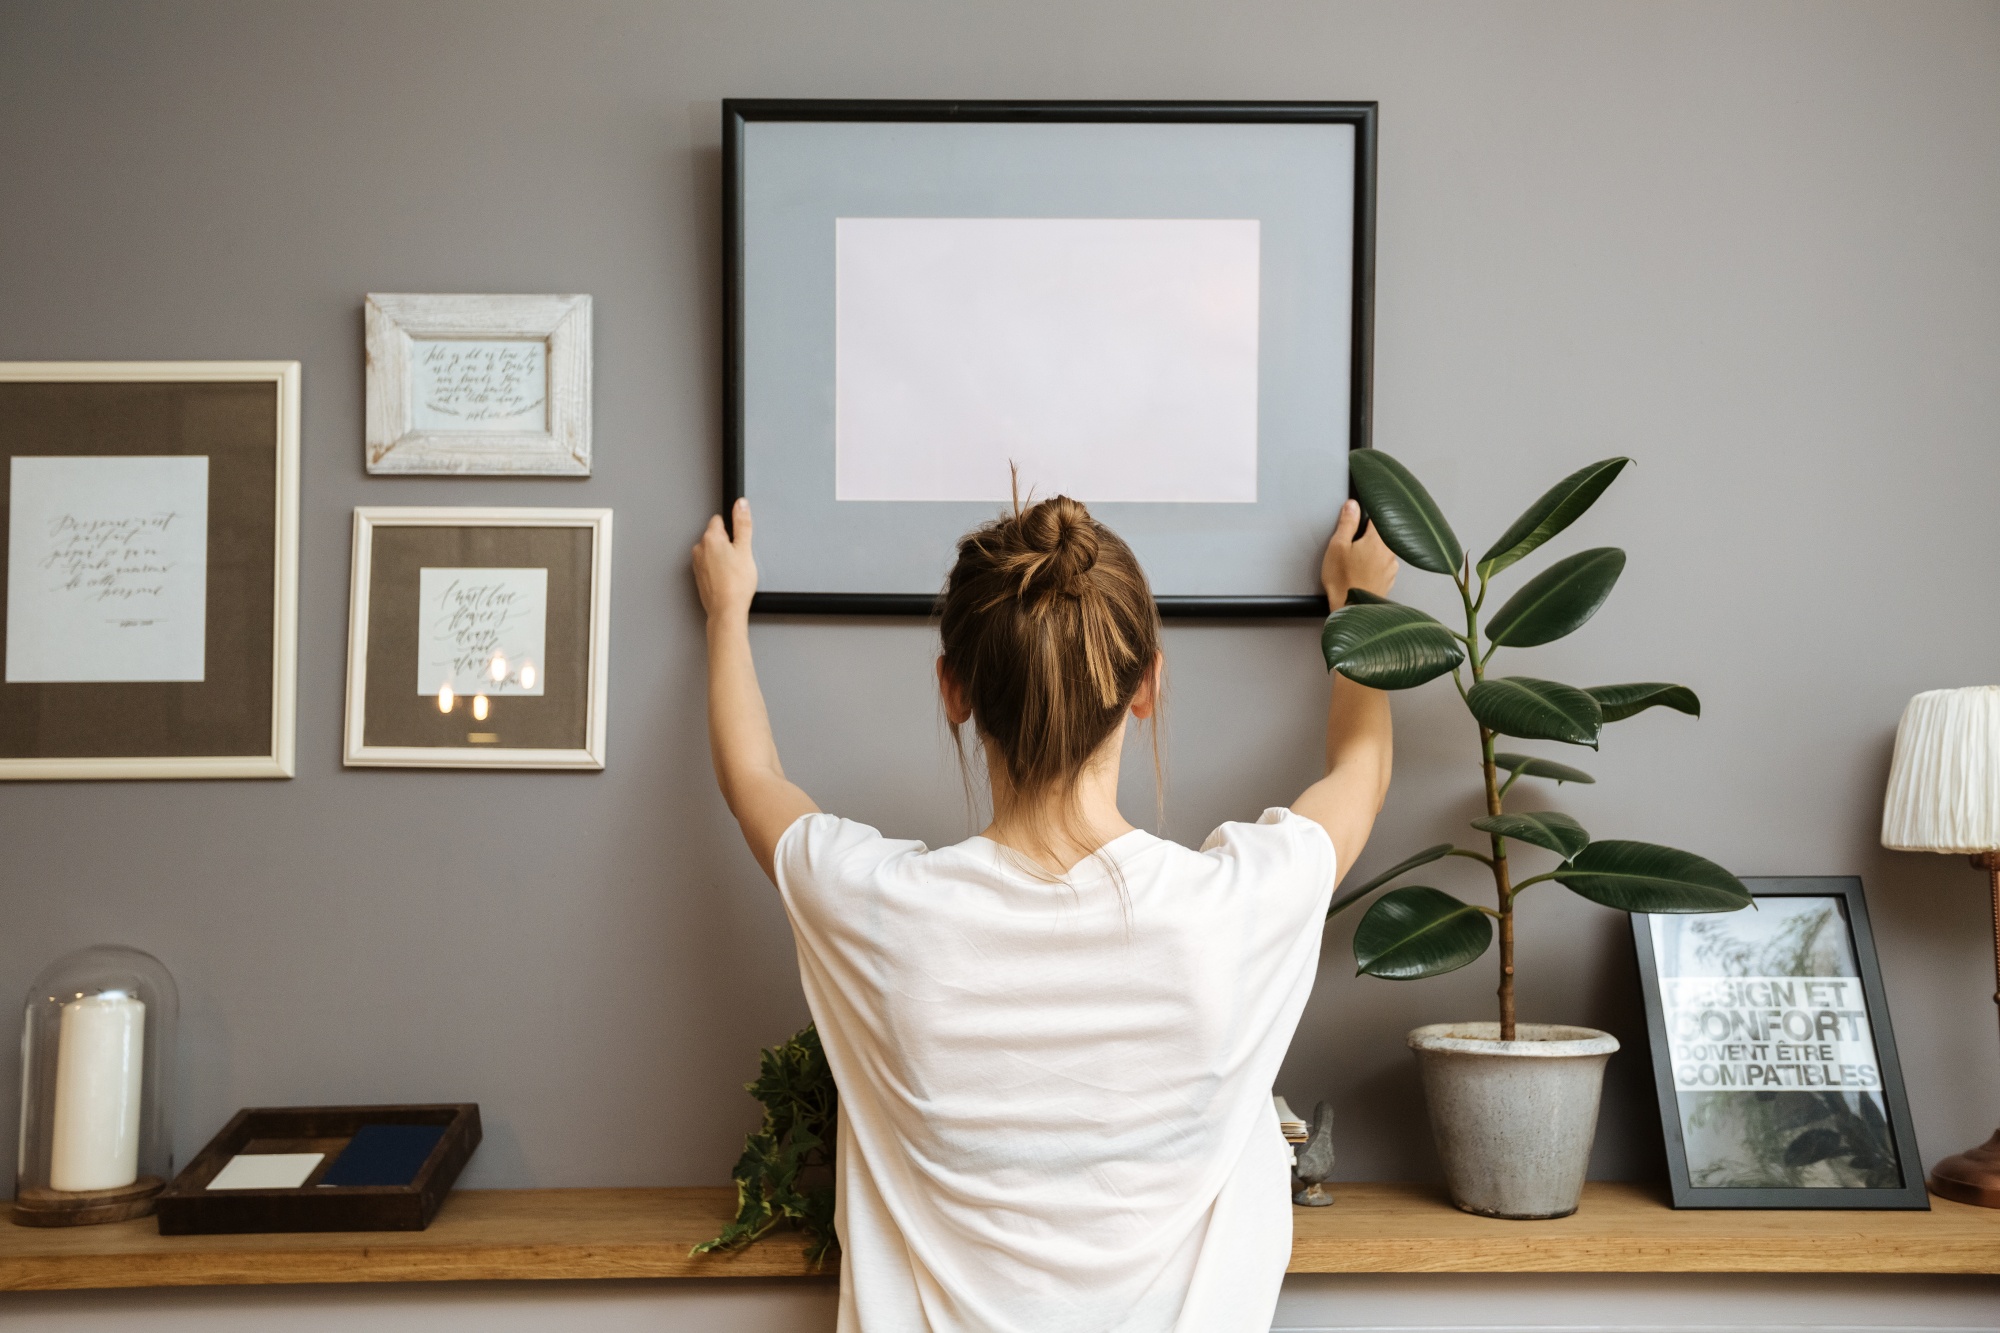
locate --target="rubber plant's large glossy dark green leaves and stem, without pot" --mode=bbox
[1320,448,1750,1041]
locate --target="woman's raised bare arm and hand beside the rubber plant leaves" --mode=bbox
[1292,500,1396,875]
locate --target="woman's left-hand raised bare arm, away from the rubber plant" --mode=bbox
[694,500,820,883]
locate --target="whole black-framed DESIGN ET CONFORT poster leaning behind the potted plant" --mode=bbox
[1632,877,1930,1209]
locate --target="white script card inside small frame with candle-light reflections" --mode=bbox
[416,568,548,697]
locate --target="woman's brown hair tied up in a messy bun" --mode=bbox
[938,494,1160,849]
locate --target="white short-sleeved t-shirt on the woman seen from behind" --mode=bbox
[776,809,1334,1333]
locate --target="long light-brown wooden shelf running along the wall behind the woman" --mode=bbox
[0,1183,2000,1291]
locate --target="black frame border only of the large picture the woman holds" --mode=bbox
[722,98,1378,618]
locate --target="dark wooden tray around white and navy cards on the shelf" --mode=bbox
[160,1101,480,1235]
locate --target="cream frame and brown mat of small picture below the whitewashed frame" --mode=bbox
[342,506,612,769]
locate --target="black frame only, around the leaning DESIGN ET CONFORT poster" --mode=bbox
[1630,875,1930,1211]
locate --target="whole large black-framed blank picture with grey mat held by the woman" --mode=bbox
[722,100,1376,616]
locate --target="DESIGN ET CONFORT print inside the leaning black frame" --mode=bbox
[1652,895,1902,1189]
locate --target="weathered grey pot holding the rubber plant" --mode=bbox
[1410,1023,1618,1219]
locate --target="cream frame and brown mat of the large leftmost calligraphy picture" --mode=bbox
[0,360,300,781]
